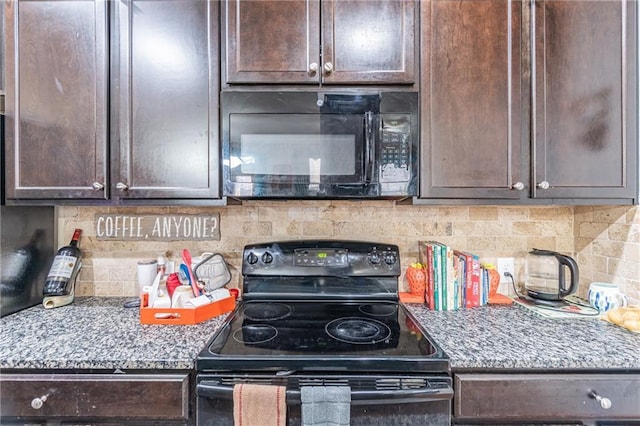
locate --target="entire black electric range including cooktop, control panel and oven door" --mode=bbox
[196,240,453,426]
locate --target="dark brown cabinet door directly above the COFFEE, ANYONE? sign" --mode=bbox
[112,0,220,199]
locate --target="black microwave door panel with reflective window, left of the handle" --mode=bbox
[225,113,366,197]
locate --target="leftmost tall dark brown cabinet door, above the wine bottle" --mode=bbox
[3,0,108,199]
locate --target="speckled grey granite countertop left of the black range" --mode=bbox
[0,297,226,370]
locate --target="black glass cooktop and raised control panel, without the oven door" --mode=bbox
[197,240,449,373]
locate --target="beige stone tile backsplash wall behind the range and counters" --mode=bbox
[57,201,640,303]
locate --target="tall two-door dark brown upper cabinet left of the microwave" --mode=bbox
[5,0,220,204]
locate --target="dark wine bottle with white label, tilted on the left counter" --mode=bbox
[43,229,82,296]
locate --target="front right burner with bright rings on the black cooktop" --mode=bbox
[325,317,391,344]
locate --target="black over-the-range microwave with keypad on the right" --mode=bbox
[221,91,419,199]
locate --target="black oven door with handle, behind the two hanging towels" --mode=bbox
[196,374,453,426]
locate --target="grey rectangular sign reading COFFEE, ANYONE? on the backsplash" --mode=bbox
[95,213,220,241]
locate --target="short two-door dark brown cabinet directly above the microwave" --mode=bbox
[222,0,418,85]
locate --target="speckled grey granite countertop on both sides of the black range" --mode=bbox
[0,297,640,371]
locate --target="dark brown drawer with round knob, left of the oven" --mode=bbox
[0,374,189,420]
